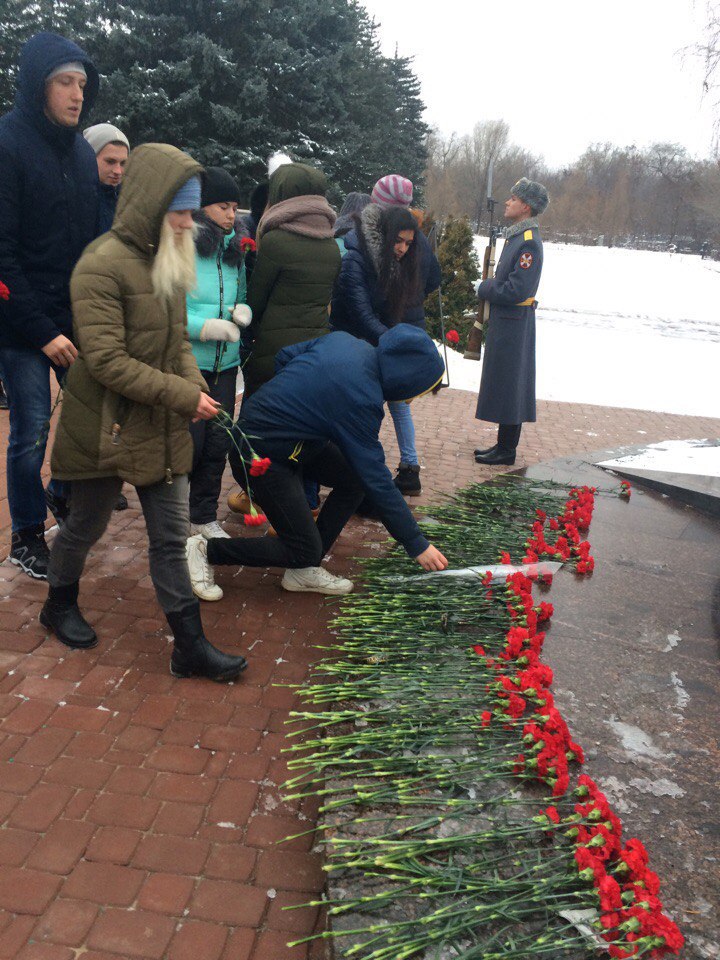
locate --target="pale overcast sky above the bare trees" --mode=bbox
[361,0,712,166]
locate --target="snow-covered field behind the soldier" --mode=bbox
[448,237,720,417]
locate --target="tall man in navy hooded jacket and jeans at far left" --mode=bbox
[0,33,99,580]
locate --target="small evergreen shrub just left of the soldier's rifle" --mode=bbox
[425,217,480,347]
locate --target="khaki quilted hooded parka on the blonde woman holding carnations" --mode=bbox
[52,143,207,487]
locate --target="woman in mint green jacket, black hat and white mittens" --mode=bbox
[187,167,252,552]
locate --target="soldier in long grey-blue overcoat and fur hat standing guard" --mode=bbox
[475,177,548,464]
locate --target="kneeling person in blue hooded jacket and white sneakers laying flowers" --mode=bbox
[183,323,448,594]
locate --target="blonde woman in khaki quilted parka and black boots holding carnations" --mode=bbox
[40,144,246,681]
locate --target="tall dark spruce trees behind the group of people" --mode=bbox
[0,0,428,199]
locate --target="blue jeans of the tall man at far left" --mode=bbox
[0,347,68,532]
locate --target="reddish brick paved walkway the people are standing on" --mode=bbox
[0,390,720,960]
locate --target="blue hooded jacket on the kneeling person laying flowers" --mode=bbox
[238,323,445,557]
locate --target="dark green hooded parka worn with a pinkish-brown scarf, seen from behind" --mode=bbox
[243,163,341,396]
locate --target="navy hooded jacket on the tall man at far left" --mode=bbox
[0,33,99,349]
